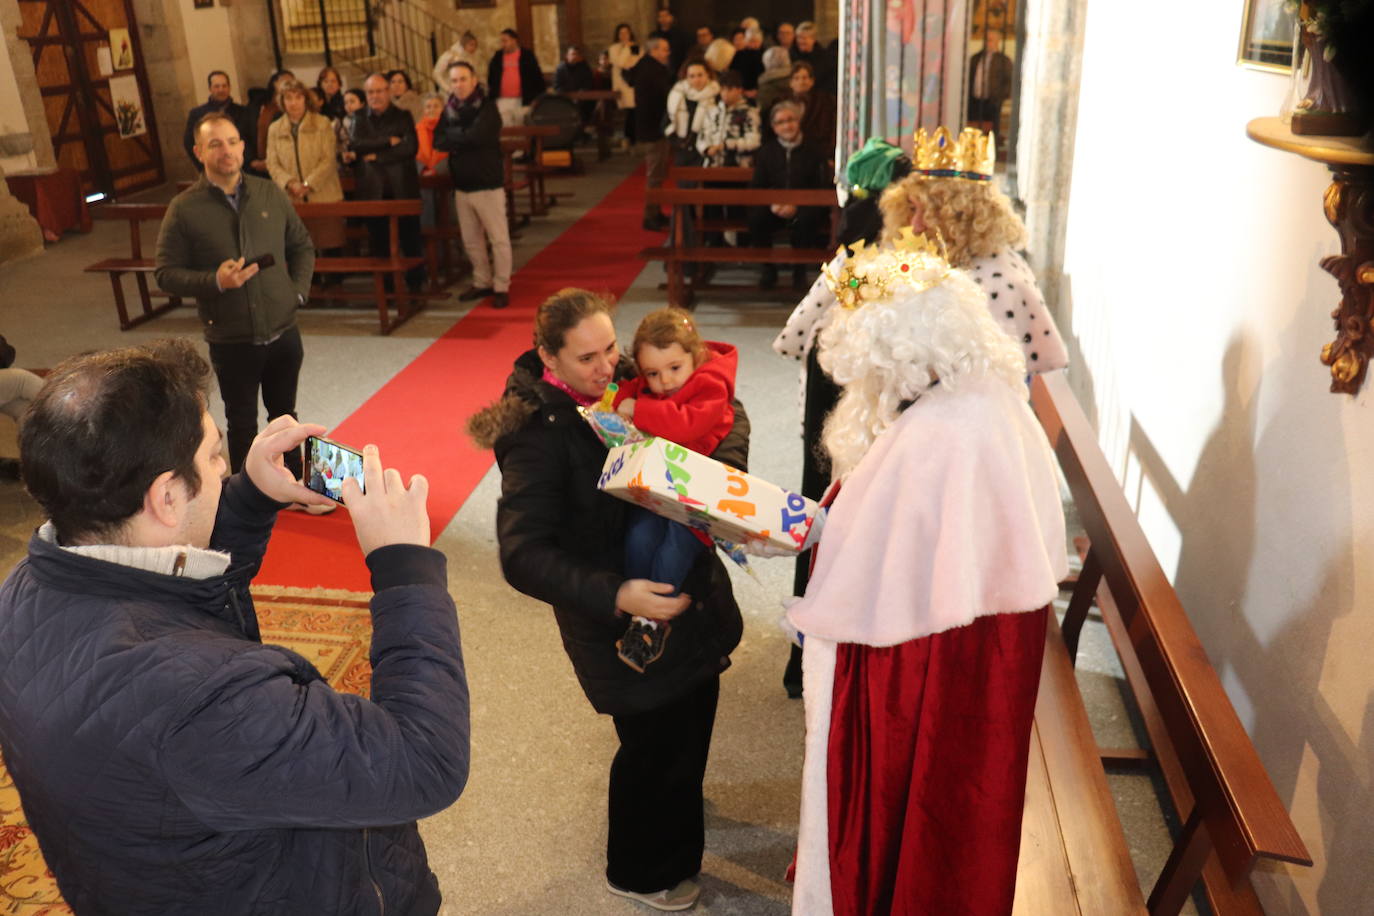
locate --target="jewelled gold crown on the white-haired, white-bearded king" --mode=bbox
[820,225,949,309]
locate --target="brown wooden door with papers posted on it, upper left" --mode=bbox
[19,0,164,198]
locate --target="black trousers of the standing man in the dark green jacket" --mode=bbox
[210,327,305,479]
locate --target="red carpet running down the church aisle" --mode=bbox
[256,169,662,592]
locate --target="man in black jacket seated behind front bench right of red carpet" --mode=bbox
[749,100,830,290]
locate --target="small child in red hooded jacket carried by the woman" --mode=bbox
[616,308,739,672]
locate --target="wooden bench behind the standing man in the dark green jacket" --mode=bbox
[85,199,433,334]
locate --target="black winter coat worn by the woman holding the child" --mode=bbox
[470,350,749,715]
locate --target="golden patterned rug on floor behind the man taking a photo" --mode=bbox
[0,586,372,916]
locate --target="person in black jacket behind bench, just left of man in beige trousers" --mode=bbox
[349,73,425,293]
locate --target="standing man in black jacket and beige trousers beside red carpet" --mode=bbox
[434,60,511,309]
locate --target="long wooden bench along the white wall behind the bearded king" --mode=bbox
[1013,372,1312,916]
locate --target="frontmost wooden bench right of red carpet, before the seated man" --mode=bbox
[639,184,838,309]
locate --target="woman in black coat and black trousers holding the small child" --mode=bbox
[469,290,749,909]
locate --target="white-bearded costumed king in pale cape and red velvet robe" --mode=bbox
[789,239,1068,915]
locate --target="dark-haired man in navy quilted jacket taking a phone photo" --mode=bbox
[0,341,469,916]
